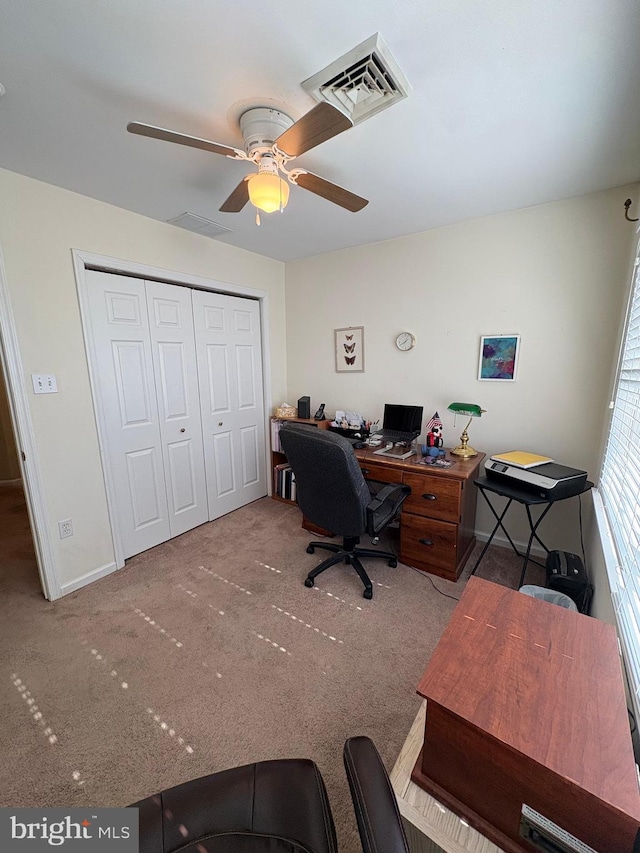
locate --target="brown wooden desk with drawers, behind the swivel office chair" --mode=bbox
[356,448,485,581]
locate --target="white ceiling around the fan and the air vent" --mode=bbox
[0,0,640,260]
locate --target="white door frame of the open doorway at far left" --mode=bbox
[0,241,62,601]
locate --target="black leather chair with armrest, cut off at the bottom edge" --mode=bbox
[133,737,408,853]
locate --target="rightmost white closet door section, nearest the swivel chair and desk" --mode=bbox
[193,291,267,519]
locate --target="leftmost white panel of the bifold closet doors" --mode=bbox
[87,270,170,559]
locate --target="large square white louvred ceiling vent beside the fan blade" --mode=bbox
[302,33,411,124]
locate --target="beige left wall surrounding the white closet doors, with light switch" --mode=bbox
[0,170,286,585]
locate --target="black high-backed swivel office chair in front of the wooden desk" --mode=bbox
[280,423,411,598]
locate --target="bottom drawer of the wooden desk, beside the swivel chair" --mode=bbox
[400,512,458,581]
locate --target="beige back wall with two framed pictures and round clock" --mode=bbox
[286,187,636,553]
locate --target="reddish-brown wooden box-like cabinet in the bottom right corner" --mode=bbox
[412,577,640,853]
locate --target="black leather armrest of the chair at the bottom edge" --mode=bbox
[343,737,409,853]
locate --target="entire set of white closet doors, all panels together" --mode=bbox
[87,271,266,559]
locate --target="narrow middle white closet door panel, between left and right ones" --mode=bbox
[145,281,209,536]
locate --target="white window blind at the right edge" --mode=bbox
[599,243,640,707]
